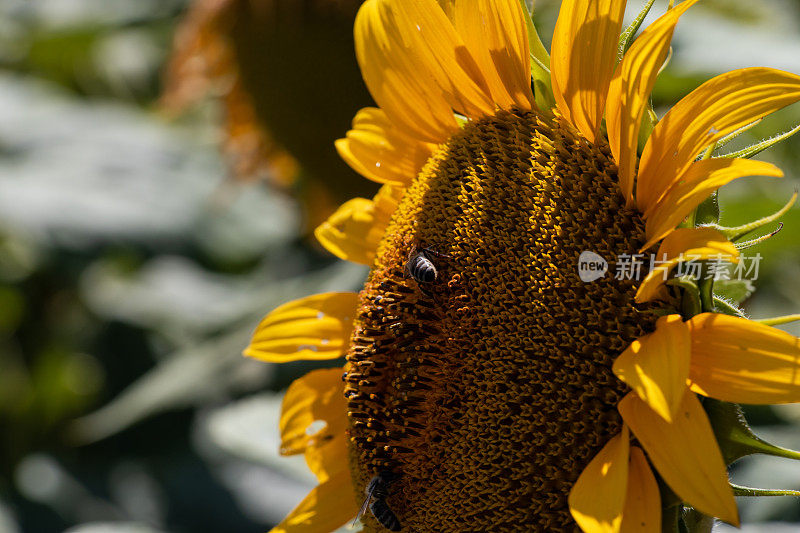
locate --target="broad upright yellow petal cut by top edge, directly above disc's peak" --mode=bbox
[453,0,533,109]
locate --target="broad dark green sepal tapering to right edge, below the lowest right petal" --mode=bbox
[703,398,800,465]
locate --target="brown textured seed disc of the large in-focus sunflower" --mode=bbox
[345,111,654,532]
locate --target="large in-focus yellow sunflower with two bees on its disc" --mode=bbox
[245,0,800,532]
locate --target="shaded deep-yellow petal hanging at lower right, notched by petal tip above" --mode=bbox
[619,389,739,526]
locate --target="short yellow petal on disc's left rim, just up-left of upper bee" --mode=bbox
[314,185,405,266]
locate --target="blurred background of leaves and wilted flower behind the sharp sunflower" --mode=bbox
[0,0,800,533]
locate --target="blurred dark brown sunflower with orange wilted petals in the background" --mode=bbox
[161,0,373,227]
